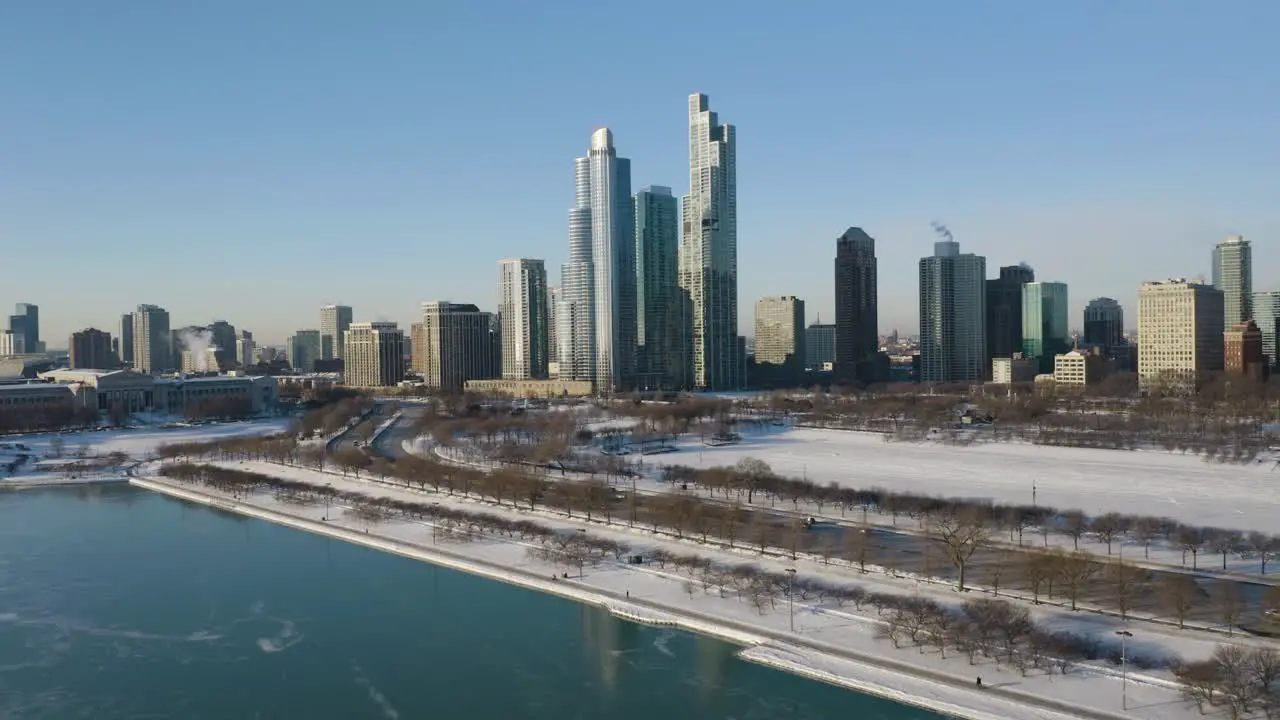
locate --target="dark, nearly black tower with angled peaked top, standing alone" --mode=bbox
[836,228,887,383]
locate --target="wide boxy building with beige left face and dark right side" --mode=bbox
[419,301,502,393]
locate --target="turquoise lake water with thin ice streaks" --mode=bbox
[0,487,938,720]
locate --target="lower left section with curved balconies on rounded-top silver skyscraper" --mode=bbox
[556,158,595,380]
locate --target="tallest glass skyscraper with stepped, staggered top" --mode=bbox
[680,94,742,389]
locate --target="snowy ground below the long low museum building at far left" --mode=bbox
[0,418,288,487]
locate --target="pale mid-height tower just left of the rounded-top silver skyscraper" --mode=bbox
[498,258,549,380]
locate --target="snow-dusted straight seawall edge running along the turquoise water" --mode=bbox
[129,477,1120,720]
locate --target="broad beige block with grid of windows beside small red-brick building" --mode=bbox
[1138,278,1224,392]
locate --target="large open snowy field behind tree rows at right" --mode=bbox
[632,428,1280,533]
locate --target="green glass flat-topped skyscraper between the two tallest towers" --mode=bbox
[635,186,687,389]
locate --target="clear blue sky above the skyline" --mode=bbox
[0,0,1280,346]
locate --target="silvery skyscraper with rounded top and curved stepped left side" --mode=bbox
[556,128,636,393]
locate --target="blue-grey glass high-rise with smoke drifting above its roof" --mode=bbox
[921,240,988,383]
